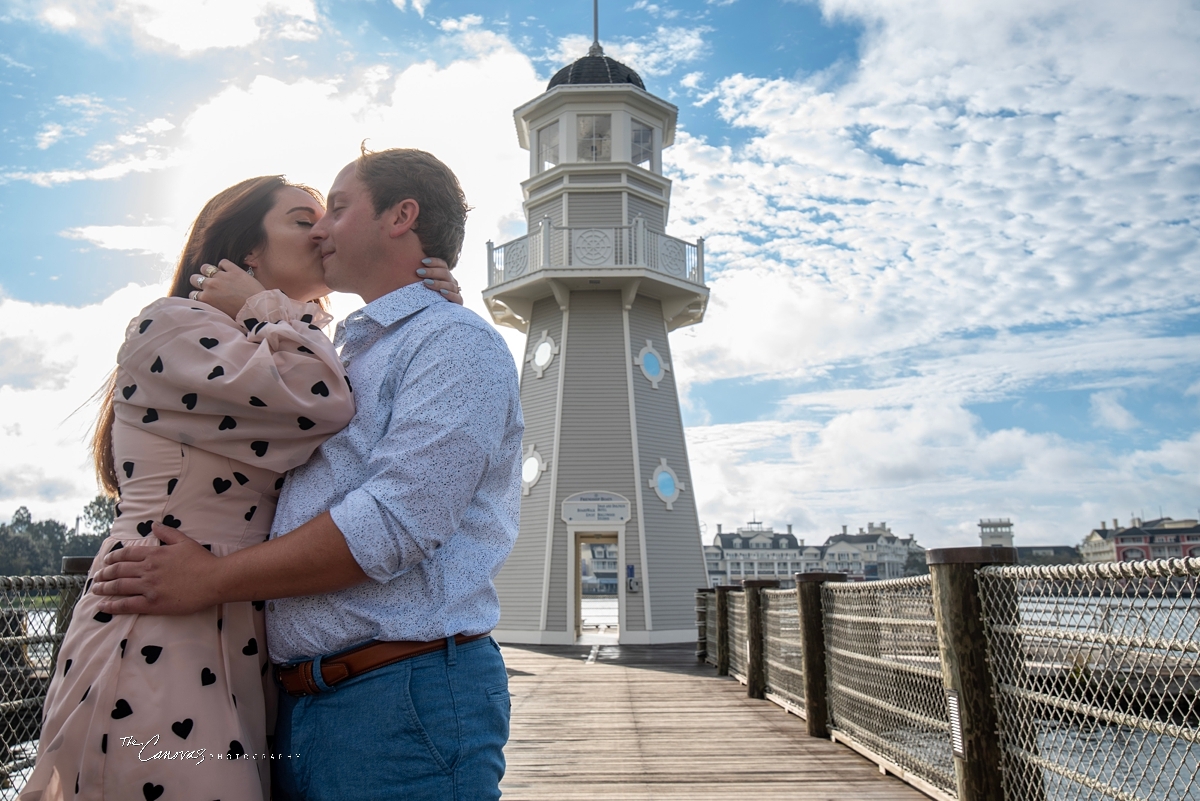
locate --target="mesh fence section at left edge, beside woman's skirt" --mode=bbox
[0,576,86,800]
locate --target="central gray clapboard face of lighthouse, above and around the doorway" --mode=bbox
[547,291,648,631]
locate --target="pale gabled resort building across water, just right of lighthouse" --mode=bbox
[704,520,925,586]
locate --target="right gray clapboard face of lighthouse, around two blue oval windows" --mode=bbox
[629,295,708,630]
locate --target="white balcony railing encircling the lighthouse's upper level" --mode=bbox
[487,217,704,287]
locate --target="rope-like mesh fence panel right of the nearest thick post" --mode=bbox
[979,559,1200,801]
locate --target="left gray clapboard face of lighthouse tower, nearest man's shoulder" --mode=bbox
[496,297,563,631]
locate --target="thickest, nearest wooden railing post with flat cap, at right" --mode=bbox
[925,547,1016,801]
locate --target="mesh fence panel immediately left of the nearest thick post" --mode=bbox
[821,576,956,797]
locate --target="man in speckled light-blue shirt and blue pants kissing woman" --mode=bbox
[95,150,523,801]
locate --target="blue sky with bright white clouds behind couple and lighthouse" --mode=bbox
[0,0,1200,546]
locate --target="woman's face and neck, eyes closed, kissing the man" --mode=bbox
[245,186,329,301]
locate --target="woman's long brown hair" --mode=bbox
[91,175,325,498]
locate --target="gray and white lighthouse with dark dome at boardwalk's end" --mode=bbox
[484,29,708,644]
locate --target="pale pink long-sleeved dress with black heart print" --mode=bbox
[19,290,354,801]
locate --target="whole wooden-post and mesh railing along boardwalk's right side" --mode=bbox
[697,548,1200,801]
